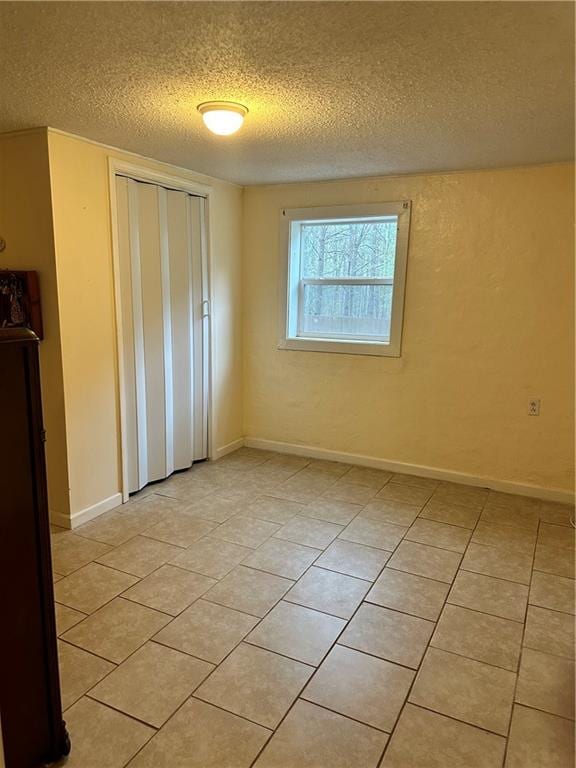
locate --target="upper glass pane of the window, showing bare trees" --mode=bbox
[300,216,398,278]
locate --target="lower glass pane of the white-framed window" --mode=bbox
[300,285,392,339]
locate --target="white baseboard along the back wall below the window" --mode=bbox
[243,437,574,504]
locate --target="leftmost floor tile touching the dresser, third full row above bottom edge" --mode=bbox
[54,563,138,613]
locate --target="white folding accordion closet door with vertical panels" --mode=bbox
[116,176,207,493]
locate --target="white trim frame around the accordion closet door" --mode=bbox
[108,157,214,502]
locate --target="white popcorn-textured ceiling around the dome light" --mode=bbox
[0,2,574,184]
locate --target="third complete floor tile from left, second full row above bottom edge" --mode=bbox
[246,600,346,666]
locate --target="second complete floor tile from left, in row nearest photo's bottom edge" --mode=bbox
[194,643,314,728]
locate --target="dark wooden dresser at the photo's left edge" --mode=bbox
[0,329,69,768]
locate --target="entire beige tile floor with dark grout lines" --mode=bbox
[53,448,574,768]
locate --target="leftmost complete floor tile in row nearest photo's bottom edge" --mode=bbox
[90,643,215,728]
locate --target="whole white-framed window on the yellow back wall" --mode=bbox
[279,202,410,357]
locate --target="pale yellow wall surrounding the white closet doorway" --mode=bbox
[49,131,242,515]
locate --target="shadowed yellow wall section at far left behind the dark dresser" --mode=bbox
[0,128,70,517]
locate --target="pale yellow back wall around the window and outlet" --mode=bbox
[244,165,574,490]
